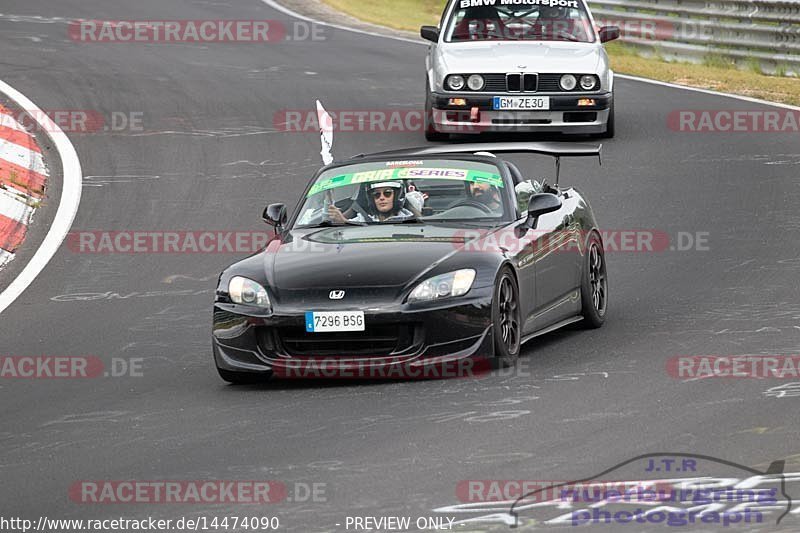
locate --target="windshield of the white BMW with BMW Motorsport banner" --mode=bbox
[445,0,595,43]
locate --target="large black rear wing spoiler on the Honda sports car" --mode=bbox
[354,142,603,186]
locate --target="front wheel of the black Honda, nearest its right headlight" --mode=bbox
[492,268,522,368]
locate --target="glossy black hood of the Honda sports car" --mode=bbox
[221,224,506,310]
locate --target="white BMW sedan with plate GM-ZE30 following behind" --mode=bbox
[420,0,619,141]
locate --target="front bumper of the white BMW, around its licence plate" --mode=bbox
[431,93,613,134]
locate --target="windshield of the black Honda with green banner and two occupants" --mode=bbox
[295,159,512,227]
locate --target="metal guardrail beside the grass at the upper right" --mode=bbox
[589,0,800,75]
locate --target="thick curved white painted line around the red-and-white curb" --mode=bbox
[0,81,82,313]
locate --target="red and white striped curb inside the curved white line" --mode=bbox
[0,105,50,268]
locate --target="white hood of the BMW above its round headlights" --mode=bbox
[437,41,602,74]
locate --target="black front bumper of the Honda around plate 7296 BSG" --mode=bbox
[212,287,494,378]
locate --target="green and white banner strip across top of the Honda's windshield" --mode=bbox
[306,167,503,197]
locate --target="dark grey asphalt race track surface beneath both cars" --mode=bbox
[0,0,800,532]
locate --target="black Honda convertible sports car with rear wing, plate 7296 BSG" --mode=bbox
[213,143,608,383]
